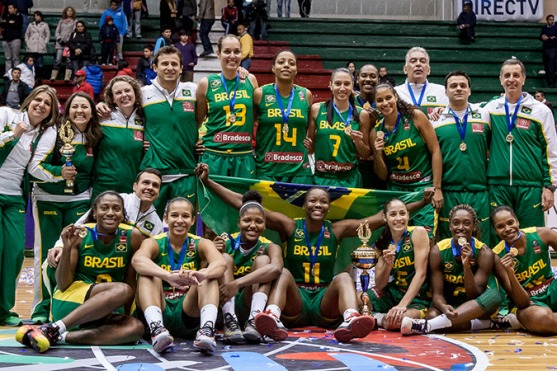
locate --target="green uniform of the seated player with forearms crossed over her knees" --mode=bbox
[153,233,202,338]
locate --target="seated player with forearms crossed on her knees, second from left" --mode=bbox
[132,197,226,353]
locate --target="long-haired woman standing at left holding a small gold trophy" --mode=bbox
[29,92,102,323]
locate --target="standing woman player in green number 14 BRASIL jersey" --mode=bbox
[253,50,313,184]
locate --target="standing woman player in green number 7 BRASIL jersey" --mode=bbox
[307,68,371,188]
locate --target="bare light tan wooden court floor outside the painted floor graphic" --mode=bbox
[7,258,557,371]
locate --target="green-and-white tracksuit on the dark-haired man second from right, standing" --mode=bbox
[433,108,491,240]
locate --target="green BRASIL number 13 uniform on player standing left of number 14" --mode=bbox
[201,74,255,178]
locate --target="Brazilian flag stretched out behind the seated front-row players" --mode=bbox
[197,175,423,273]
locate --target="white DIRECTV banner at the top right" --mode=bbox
[454,0,543,22]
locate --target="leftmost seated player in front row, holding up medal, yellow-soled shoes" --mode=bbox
[16,191,144,352]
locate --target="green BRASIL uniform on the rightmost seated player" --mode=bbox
[493,227,557,312]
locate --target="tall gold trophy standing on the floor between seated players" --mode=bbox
[350,220,378,315]
